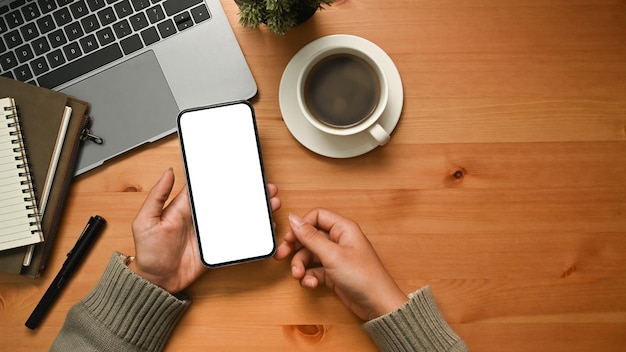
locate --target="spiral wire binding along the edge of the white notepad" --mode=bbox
[4,105,42,234]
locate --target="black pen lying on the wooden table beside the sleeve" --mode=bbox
[26,215,106,330]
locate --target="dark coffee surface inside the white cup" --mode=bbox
[304,54,380,127]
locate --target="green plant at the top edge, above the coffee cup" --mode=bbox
[235,0,334,35]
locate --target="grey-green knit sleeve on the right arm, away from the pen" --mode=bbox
[363,287,469,352]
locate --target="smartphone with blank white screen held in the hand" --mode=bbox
[177,101,276,267]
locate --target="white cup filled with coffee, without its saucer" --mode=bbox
[296,46,390,145]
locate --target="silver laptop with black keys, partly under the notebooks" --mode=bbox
[0,0,257,175]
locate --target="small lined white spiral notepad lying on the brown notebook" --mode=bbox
[0,97,43,250]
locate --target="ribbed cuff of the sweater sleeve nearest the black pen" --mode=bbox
[79,253,190,351]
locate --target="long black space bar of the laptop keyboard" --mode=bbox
[38,43,123,88]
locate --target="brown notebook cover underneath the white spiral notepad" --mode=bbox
[0,77,88,277]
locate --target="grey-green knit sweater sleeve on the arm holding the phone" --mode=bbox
[50,253,190,351]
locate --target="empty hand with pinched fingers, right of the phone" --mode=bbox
[274,209,408,321]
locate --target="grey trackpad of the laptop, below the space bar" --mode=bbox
[62,51,179,174]
